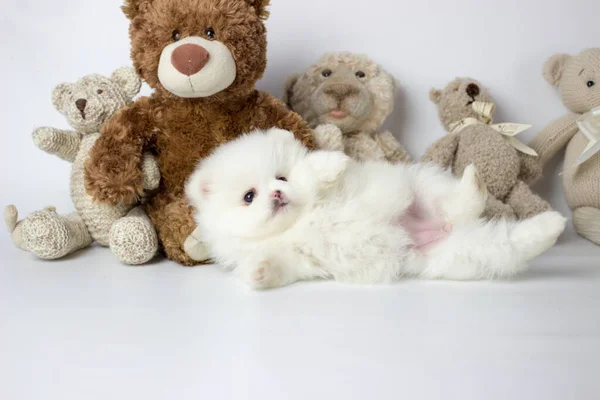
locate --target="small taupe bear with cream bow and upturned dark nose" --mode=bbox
[421,78,550,219]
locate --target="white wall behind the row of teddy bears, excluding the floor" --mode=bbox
[0,0,600,217]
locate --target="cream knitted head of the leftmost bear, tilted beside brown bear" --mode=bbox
[52,68,142,133]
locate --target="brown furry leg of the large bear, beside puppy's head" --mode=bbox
[145,195,209,266]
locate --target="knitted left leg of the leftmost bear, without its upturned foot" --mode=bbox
[21,209,93,260]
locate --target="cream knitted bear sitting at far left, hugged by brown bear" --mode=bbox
[5,68,160,265]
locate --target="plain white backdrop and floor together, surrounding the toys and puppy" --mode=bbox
[0,0,600,400]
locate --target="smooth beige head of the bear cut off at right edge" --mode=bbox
[544,48,600,114]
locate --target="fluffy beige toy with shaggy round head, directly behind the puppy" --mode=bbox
[284,53,411,163]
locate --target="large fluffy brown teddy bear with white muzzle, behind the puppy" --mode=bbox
[86,0,314,265]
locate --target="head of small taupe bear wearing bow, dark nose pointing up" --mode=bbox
[429,78,494,131]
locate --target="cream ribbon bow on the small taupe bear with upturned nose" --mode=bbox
[450,101,538,157]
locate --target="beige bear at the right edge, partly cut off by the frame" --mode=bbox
[531,48,600,245]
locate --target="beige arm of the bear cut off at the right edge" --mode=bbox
[530,114,579,167]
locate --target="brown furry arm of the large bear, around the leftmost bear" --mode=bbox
[85,98,154,204]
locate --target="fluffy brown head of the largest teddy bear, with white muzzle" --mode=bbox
[123,0,269,100]
